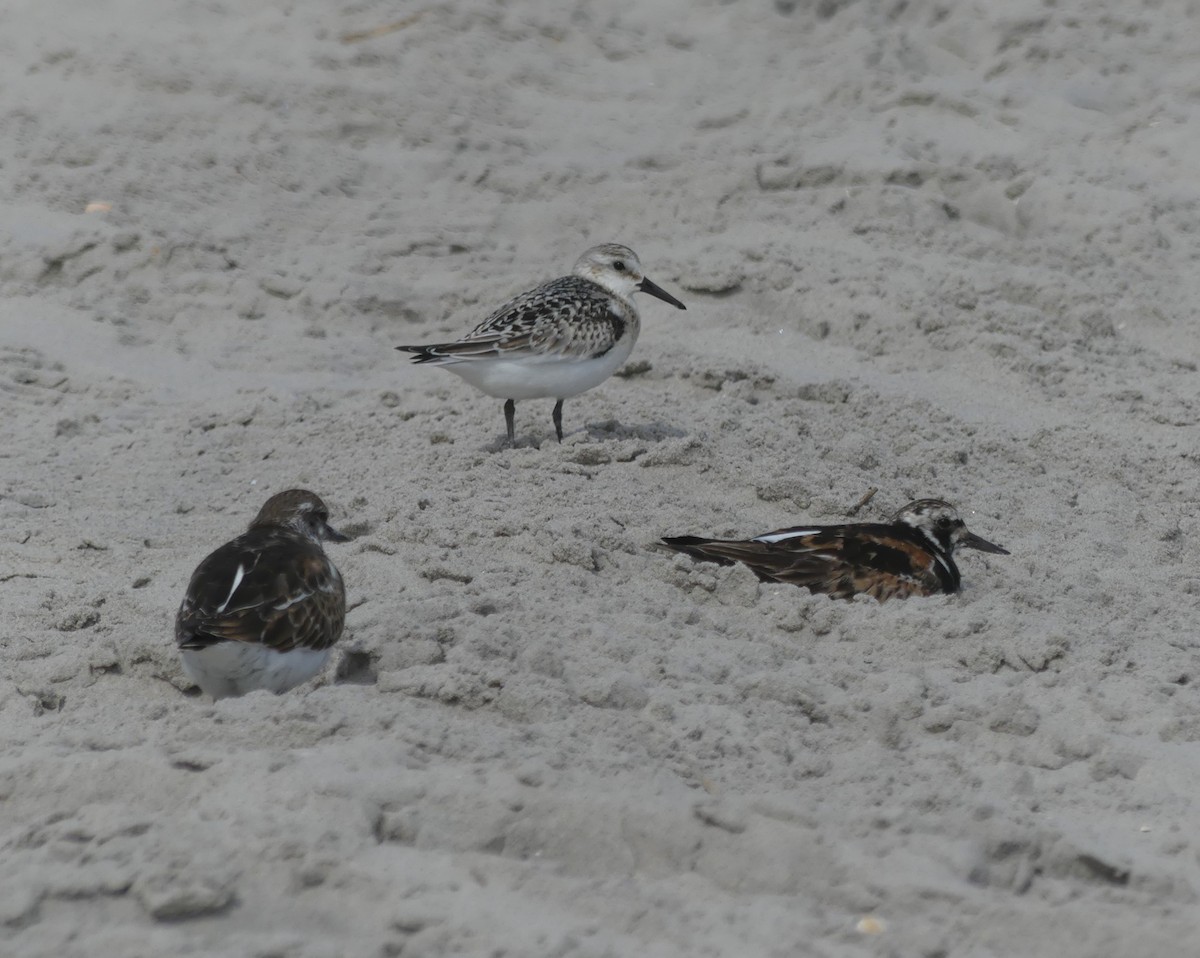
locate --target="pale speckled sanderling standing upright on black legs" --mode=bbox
[396,243,686,445]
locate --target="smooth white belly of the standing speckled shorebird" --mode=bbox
[445,336,634,400]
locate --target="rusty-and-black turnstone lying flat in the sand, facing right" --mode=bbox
[662,499,1008,601]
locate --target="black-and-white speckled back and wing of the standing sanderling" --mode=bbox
[397,276,628,364]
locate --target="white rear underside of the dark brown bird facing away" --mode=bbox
[180,641,330,699]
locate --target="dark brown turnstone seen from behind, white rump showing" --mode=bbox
[175,489,347,699]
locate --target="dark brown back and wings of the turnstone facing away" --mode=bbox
[175,533,346,652]
